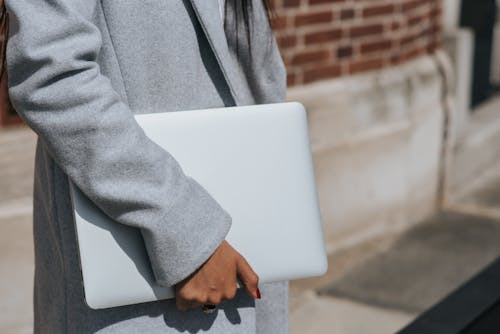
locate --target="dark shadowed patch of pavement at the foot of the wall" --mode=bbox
[319,211,500,314]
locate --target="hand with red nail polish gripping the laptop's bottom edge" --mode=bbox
[175,240,260,311]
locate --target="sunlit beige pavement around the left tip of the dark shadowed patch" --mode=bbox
[290,232,416,334]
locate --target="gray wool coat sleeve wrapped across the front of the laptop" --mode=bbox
[6,0,231,286]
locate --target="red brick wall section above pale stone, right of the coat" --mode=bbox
[272,0,443,86]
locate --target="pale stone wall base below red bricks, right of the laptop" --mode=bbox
[288,56,443,250]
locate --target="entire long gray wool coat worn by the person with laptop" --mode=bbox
[6,0,287,334]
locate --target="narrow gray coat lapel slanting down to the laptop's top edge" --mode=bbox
[189,0,254,105]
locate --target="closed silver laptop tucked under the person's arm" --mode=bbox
[70,102,327,309]
